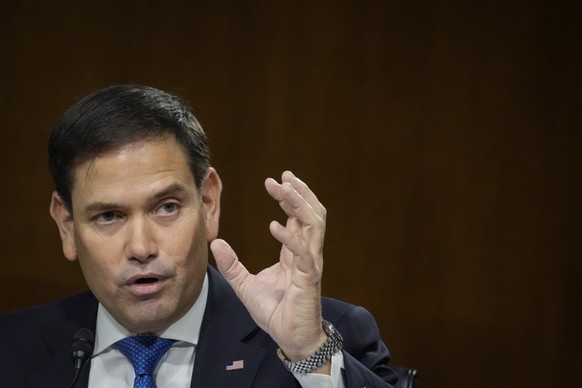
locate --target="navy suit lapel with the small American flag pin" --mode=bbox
[191,266,266,388]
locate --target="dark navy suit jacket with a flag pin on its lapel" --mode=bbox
[0,266,397,388]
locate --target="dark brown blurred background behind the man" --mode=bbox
[0,0,582,388]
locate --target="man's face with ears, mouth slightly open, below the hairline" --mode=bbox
[51,137,221,333]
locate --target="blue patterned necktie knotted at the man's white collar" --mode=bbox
[115,335,176,388]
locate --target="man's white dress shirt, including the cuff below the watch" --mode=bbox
[89,275,344,388]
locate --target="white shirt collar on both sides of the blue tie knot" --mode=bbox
[93,273,208,355]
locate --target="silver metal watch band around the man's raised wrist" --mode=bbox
[277,320,344,375]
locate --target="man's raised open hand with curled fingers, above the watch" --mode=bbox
[211,171,326,360]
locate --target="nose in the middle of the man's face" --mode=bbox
[126,216,158,263]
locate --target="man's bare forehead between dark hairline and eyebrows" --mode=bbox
[72,137,195,203]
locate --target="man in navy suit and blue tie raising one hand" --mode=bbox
[0,85,395,388]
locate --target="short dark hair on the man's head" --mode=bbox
[48,85,210,212]
